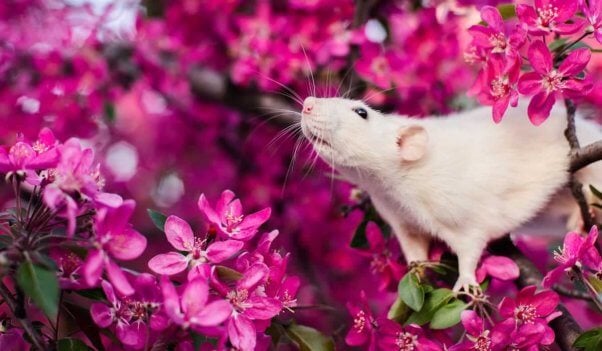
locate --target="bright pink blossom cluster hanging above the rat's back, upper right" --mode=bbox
[467,0,602,125]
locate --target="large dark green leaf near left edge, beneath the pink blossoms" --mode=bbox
[17,261,59,320]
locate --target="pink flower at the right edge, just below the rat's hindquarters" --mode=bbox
[543,226,602,288]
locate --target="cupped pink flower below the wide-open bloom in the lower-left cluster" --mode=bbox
[161,276,232,330]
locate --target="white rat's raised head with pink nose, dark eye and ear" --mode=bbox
[301,97,428,173]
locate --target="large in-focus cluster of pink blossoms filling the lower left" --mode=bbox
[0,129,300,350]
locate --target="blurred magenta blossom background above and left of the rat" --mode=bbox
[0,0,602,344]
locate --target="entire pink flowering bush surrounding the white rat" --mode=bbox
[0,0,602,351]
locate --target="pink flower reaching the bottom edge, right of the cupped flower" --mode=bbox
[212,263,282,351]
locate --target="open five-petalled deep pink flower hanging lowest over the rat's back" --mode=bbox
[518,41,592,125]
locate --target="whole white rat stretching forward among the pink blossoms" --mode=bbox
[301,97,602,291]
